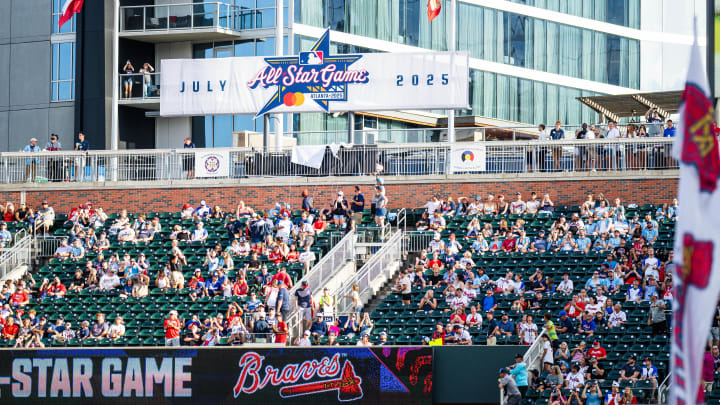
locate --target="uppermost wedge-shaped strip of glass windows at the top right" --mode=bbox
[508,0,640,29]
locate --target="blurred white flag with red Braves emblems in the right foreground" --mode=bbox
[668,33,720,405]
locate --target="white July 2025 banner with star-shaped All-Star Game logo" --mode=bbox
[160,30,469,117]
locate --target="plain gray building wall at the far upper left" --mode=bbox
[0,0,74,151]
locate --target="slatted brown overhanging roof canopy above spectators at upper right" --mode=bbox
[577,90,682,121]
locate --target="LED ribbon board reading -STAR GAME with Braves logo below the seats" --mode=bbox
[0,347,432,405]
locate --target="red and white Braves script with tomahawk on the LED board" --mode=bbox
[233,352,363,402]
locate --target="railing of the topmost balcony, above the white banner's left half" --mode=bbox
[120,2,288,32]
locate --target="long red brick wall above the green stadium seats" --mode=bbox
[0,178,677,212]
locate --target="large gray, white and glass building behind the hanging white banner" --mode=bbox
[0,0,706,151]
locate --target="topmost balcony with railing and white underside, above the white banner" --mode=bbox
[120,2,287,43]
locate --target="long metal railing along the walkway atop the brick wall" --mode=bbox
[0,138,677,183]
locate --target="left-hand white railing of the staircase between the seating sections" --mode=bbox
[286,231,356,336]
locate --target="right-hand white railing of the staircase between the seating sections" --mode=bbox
[333,231,403,312]
